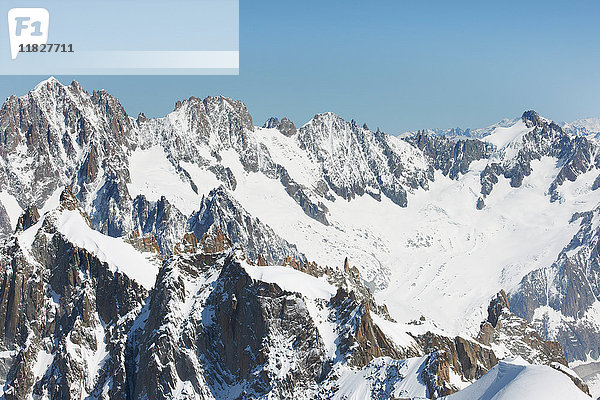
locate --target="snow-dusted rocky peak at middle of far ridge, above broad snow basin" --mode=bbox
[297,113,429,207]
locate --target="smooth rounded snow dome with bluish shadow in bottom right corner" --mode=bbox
[443,358,590,400]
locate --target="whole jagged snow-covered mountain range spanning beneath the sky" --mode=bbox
[0,78,600,399]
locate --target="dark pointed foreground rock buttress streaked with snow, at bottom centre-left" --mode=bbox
[134,253,404,399]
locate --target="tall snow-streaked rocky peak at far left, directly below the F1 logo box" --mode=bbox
[0,79,132,235]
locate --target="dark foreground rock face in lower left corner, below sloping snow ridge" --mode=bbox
[0,191,146,399]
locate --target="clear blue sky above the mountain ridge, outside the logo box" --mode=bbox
[0,0,600,134]
